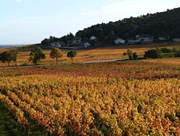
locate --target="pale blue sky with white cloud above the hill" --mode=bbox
[0,0,180,45]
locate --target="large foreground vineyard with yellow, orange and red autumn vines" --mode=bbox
[0,58,180,136]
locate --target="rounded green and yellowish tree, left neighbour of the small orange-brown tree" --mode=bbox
[29,47,45,65]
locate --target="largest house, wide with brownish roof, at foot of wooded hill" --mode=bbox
[136,34,153,43]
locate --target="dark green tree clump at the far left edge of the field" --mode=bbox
[0,50,18,66]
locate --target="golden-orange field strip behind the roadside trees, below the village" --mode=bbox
[0,42,180,66]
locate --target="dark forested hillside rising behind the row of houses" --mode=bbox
[42,8,180,44]
